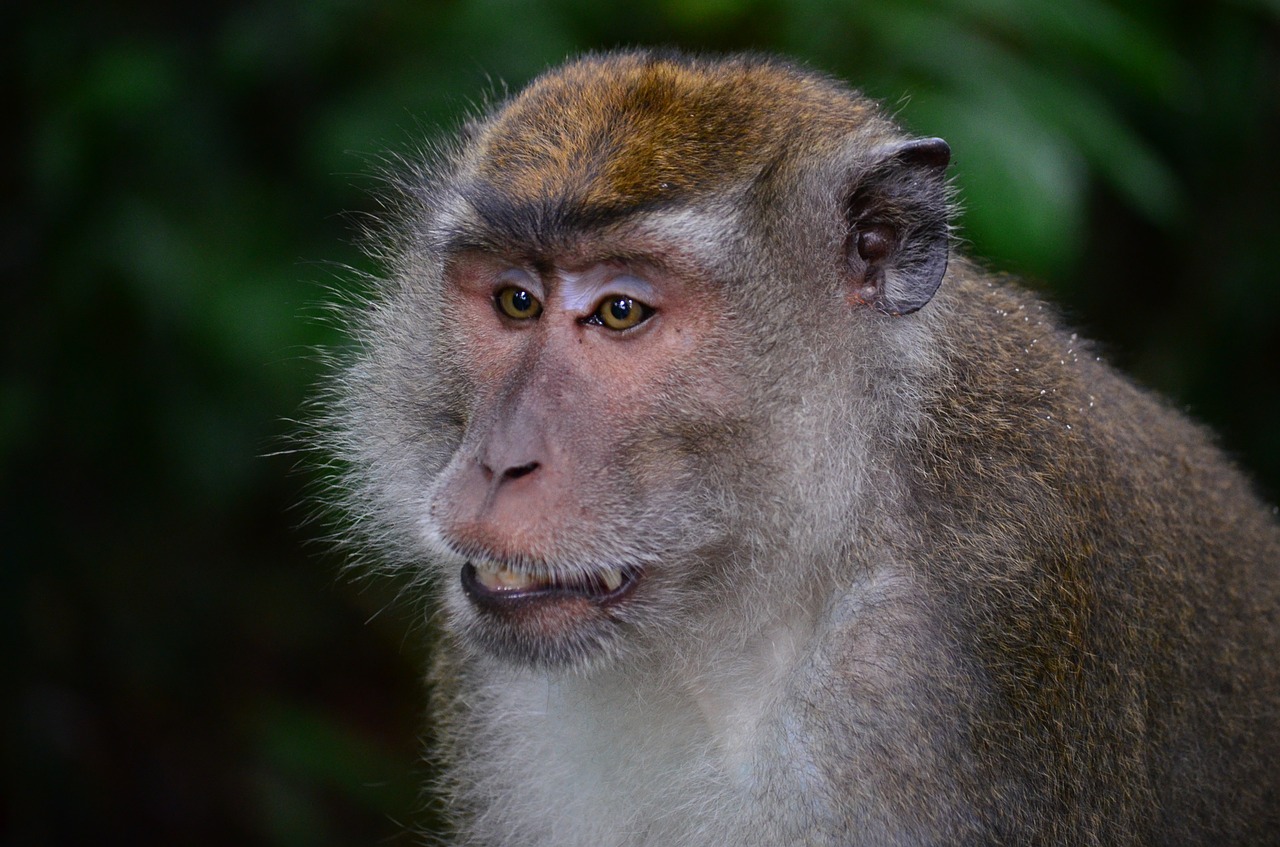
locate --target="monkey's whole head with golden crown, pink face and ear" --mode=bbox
[340,52,950,667]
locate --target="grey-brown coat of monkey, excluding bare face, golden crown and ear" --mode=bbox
[329,54,1280,847]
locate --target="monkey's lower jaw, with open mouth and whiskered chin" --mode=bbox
[461,562,643,668]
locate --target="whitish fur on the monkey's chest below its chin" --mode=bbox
[458,627,805,847]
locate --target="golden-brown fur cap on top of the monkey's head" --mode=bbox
[472,52,888,212]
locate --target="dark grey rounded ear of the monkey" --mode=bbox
[844,138,951,315]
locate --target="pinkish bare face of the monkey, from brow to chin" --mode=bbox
[419,251,735,664]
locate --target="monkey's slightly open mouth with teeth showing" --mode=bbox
[462,562,640,610]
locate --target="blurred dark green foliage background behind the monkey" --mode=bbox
[0,0,1280,846]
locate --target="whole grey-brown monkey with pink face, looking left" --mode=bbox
[325,50,1280,847]
